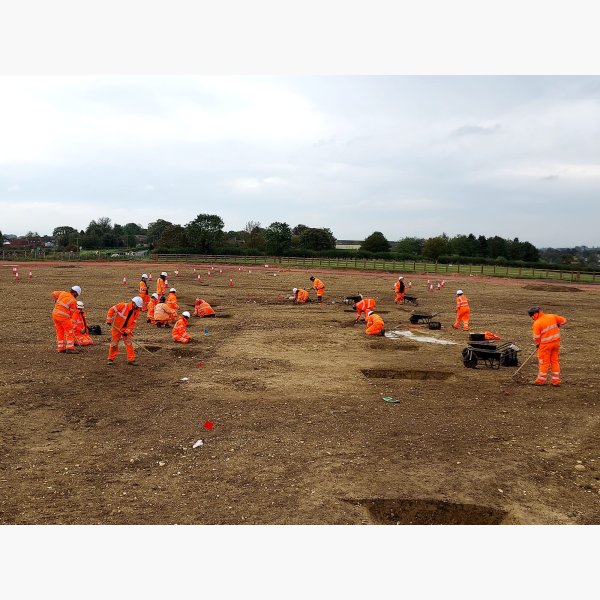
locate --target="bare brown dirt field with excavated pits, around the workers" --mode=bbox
[0,263,600,524]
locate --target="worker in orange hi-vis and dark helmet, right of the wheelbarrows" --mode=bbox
[528,306,567,386]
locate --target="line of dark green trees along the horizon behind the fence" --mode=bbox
[5,214,599,268]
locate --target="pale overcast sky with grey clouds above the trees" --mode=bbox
[0,75,600,247]
